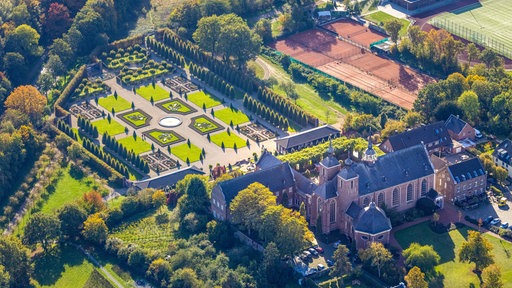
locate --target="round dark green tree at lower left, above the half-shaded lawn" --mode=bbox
[24,212,60,252]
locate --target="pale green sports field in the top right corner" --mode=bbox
[429,0,512,58]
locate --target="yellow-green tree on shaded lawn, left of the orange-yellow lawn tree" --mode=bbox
[402,243,441,273]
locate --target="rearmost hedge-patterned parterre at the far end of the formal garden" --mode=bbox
[101,44,147,70]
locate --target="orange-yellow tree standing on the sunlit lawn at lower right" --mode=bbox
[459,231,494,271]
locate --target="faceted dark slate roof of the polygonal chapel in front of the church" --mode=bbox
[354,202,391,235]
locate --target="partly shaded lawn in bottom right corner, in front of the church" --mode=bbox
[395,222,512,288]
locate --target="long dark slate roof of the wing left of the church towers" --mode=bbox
[218,163,295,205]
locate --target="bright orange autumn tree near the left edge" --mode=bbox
[4,85,46,121]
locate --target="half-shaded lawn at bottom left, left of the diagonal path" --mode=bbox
[33,246,94,287]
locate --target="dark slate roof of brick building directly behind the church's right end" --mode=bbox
[388,121,452,151]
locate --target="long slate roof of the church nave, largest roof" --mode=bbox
[338,144,434,196]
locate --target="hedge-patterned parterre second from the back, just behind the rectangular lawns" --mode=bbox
[118,60,174,85]
